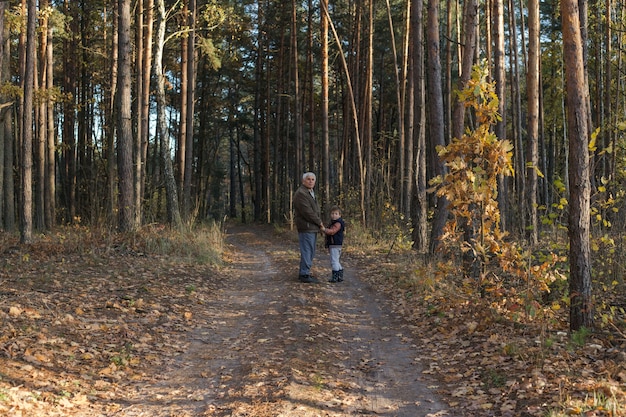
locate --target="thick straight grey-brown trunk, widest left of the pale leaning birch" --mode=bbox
[116,0,137,232]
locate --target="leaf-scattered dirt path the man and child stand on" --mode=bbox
[109,228,453,417]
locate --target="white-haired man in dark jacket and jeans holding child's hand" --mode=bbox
[293,172,325,283]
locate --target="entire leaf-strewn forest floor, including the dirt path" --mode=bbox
[0,226,626,417]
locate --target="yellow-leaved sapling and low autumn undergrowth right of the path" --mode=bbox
[346,62,626,417]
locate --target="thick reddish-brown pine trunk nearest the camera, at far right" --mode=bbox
[561,0,593,331]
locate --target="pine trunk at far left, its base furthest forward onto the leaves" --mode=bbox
[20,0,37,244]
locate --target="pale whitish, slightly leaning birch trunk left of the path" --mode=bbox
[154,0,182,229]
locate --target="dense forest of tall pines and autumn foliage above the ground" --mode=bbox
[0,0,626,336]
